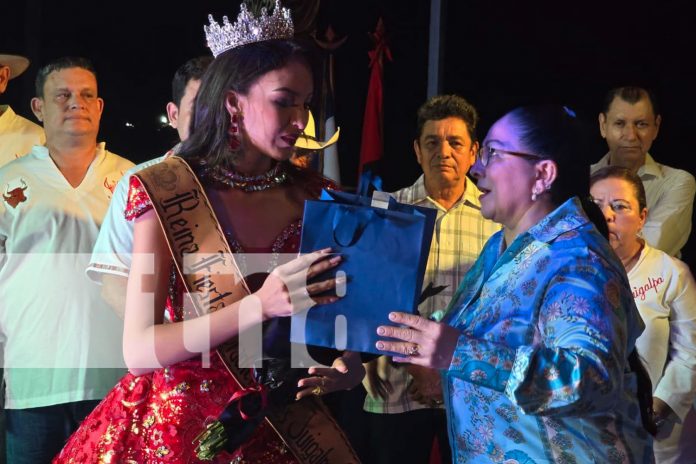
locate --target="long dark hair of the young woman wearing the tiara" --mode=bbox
[179,40,315,166]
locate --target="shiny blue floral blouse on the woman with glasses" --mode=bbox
[443,199,653,464]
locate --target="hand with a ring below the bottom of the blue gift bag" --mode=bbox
[296,351,365,400]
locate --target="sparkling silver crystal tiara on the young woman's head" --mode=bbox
[203,0,295,58]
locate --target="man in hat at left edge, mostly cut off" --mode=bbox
[0,53,45,166]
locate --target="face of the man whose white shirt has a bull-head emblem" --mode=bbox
[32,68,104,140]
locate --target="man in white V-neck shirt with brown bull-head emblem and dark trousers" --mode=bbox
[0,58,133,464]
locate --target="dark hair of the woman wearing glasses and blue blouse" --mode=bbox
[508,105,609,238]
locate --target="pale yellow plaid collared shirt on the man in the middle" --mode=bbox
[365,175,501,414]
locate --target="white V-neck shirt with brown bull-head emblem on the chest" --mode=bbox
[0,143,133,409]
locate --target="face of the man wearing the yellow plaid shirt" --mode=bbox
[413,117,478,186]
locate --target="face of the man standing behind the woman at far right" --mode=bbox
[599,97,661,169]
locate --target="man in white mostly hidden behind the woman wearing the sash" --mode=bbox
[87,56,213,317]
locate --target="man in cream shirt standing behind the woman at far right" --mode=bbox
[591,87,696,257]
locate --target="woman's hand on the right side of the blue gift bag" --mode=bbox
[377,312,461,369]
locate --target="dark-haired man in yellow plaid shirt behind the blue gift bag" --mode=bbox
[358,95,500,464]
